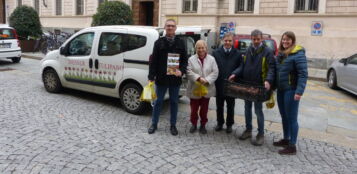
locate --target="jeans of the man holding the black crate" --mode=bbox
[244,100,264,134]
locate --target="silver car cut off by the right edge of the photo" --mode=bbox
[327,54,357,95]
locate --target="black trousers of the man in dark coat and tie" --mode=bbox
[216,96,235,126]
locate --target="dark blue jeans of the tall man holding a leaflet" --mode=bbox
[152,85,180,126]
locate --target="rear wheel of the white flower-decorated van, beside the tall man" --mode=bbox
[120,83,149,115]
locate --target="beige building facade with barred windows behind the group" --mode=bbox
[5,0,357,60]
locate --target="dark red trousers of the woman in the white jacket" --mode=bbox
[190,97,209,126]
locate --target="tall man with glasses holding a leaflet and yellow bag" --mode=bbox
[148,19,187,136]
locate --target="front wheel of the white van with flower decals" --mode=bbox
[42,69,62,93]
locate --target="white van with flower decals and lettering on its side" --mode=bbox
[41,26,209,114]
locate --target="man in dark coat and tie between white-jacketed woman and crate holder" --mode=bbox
[213,33,242,133]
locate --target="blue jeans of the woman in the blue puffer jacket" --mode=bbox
[277,90,299,145]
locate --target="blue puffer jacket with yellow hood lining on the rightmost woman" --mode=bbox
[276,45,308,95]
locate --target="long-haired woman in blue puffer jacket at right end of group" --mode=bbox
[273,31,307,155]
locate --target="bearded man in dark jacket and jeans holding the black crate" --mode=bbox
[229,30,275,146]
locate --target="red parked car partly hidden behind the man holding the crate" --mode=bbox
[233,34,278,56]
